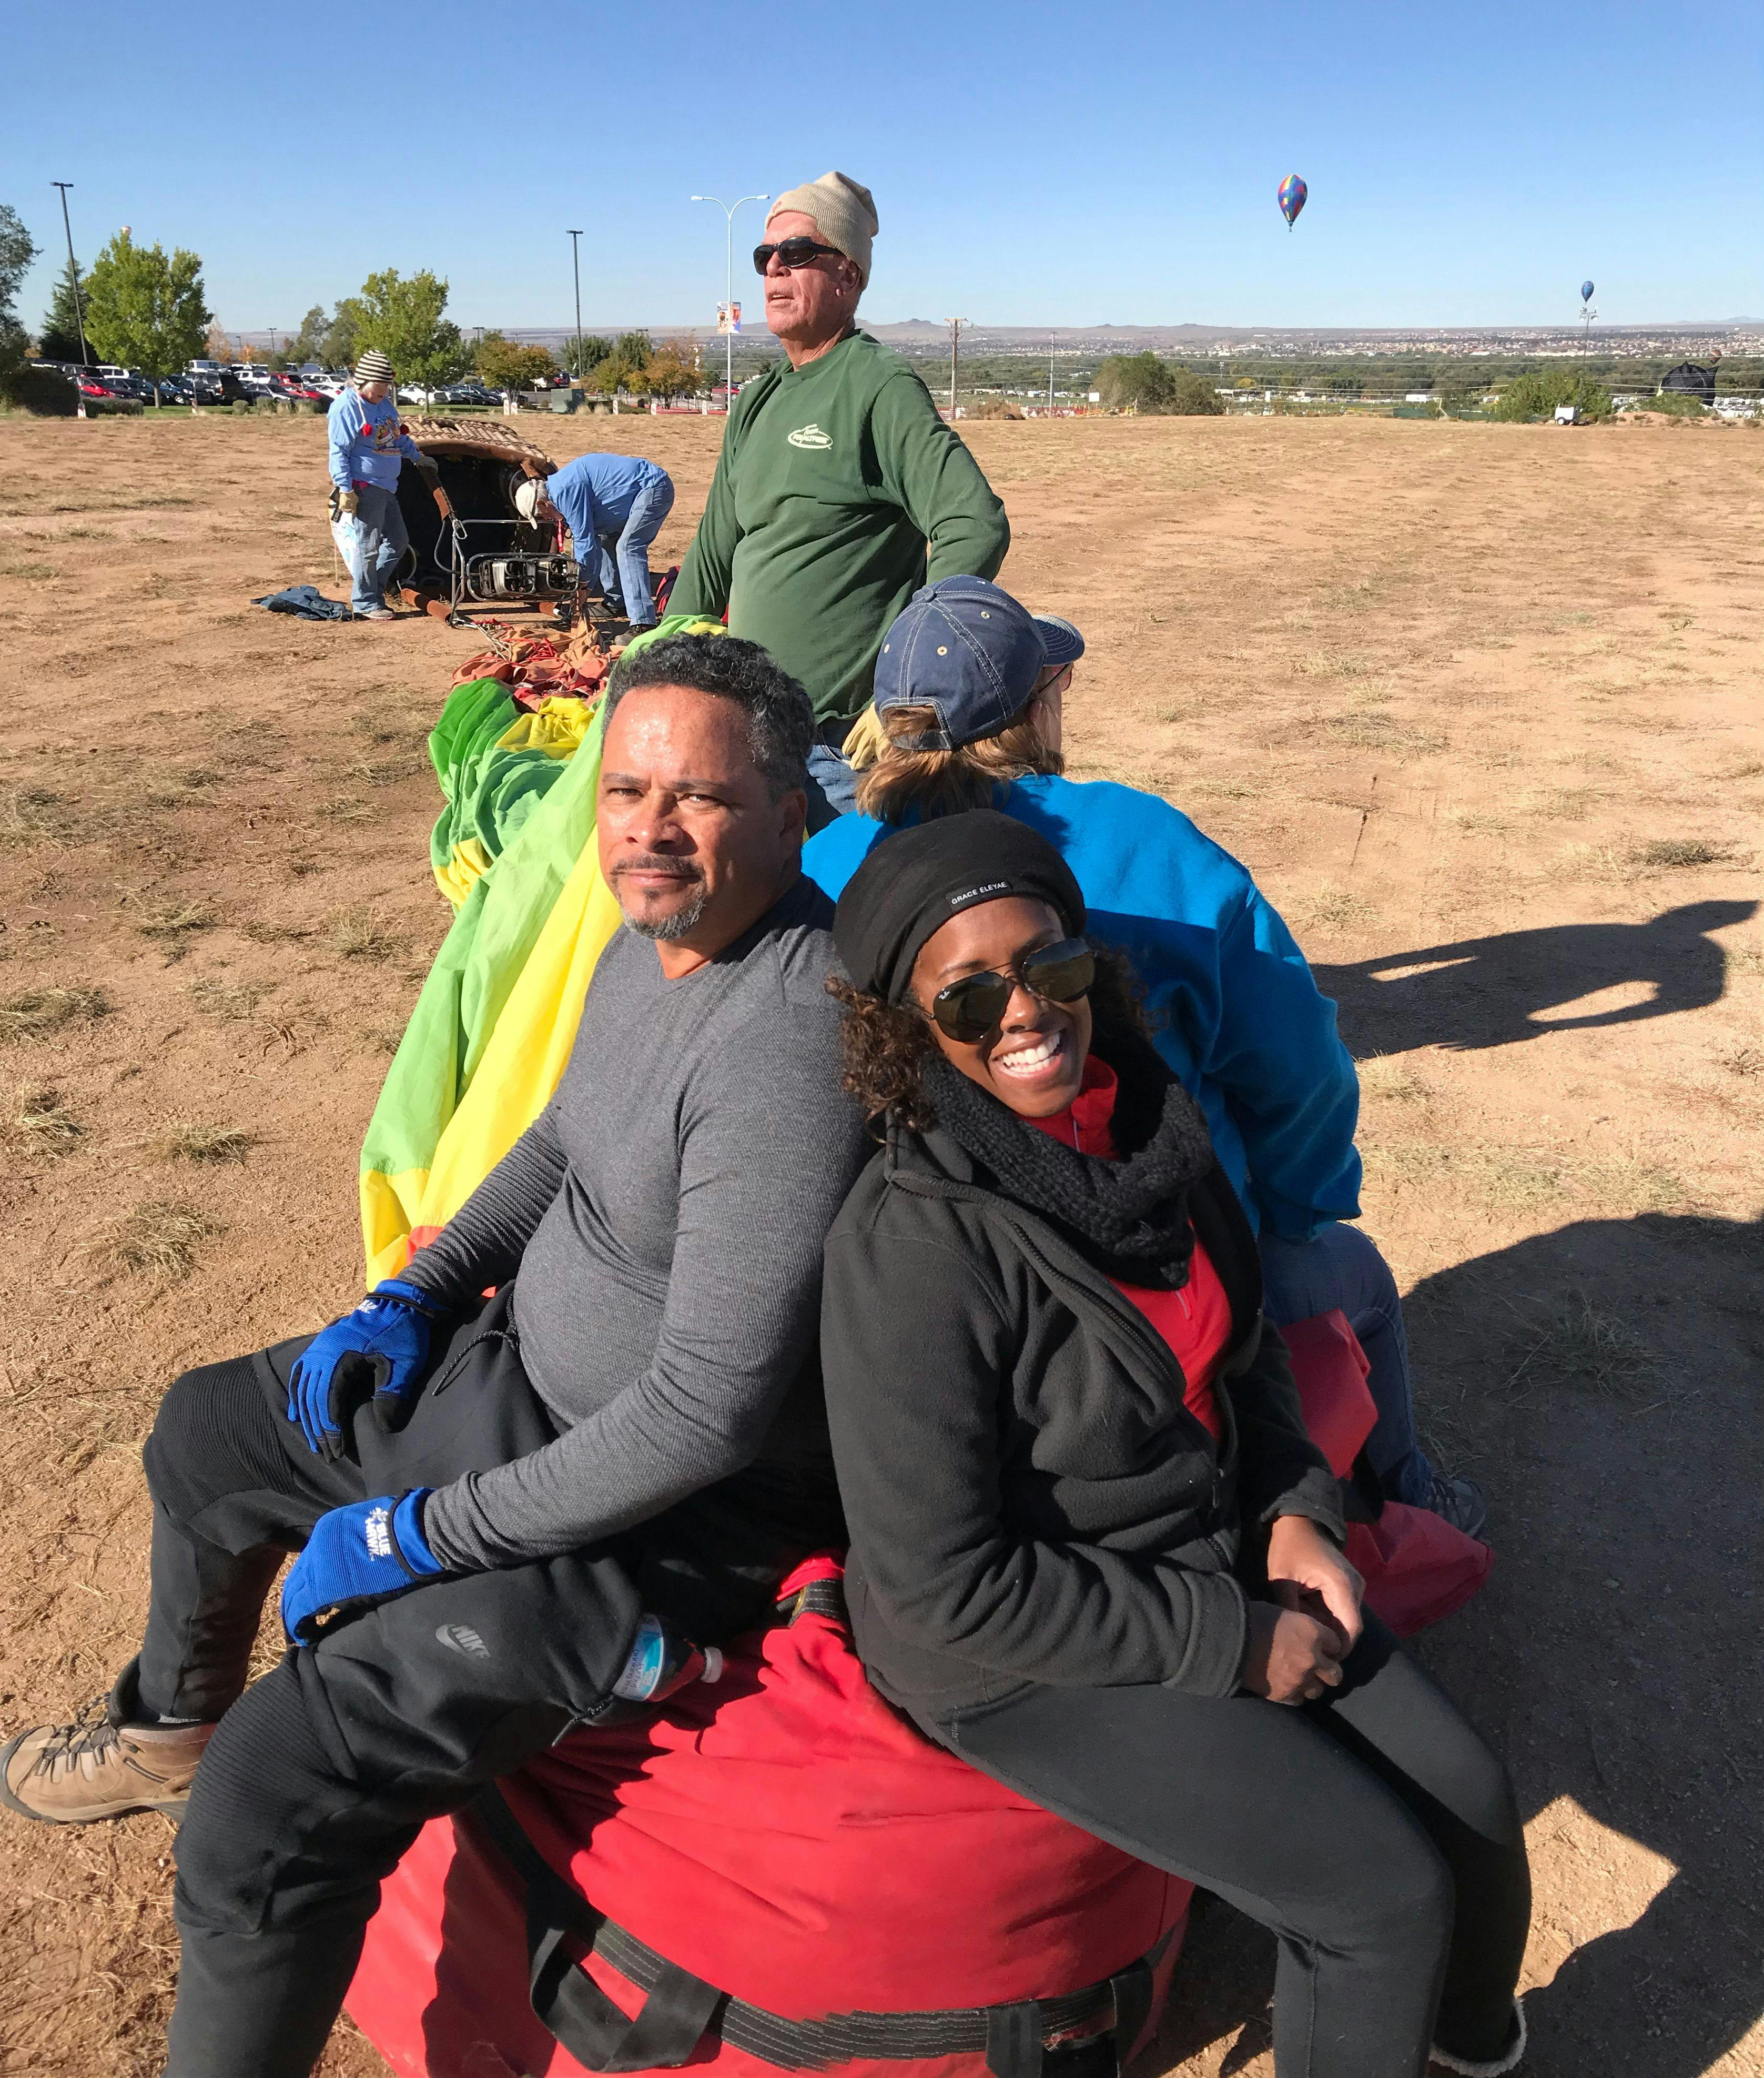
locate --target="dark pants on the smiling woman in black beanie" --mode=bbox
[925,1619,1532,2078]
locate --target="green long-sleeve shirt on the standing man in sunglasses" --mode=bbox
[669,332,1010,725]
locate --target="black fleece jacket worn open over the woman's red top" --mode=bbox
[820,1128,1344,1717]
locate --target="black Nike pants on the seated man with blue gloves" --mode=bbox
[134,1299,839,2078]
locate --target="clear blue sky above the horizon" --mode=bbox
[0,0,1764,328]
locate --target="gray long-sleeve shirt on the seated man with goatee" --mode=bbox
[405,881,864,1569]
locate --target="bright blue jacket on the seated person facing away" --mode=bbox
[802,777,1359,1240]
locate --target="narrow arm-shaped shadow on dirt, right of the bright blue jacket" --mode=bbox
[1313,902,1758,1058]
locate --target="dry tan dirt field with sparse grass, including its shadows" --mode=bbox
[0,418,1764,2078]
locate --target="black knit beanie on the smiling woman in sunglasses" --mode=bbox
[833,809,1084,1004]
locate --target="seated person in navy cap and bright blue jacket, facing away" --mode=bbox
[802,578,1488,1536]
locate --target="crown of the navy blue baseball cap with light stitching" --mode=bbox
[875,578,1047,750]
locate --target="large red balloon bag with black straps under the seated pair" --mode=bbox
[349,1560,1191,2078]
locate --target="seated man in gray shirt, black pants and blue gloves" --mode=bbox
[0,636,864,2078]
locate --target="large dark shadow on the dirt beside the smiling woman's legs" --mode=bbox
[1141,1213,1764,2078]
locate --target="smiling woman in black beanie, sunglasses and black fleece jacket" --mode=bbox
[820,811,1529,2078]
